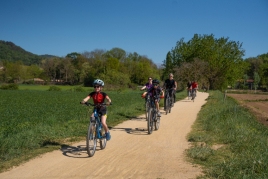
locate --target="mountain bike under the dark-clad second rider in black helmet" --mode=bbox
[147,95,160,134]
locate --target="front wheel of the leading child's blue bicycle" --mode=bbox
[86,123,97,157]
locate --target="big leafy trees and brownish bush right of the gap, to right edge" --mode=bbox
[163,34,268,89]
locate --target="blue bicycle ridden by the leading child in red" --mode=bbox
[81,102,111,157]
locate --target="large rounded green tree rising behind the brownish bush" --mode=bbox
[168,34,246,89]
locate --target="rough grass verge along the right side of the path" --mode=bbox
[187,91,268,179]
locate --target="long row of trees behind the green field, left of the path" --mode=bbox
[0,48,160,87]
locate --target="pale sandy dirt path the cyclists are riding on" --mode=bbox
[0,92,208,179]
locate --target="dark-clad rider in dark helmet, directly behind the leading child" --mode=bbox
[148,79,164,117]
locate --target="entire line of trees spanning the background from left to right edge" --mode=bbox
[0,34,268,89]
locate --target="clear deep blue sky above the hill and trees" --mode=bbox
[0,0,268,64]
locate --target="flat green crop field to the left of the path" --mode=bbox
[0,90,149,170]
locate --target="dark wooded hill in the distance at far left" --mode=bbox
[0,40,58,65]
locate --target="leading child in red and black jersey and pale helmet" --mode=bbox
[81,79,112,140]
